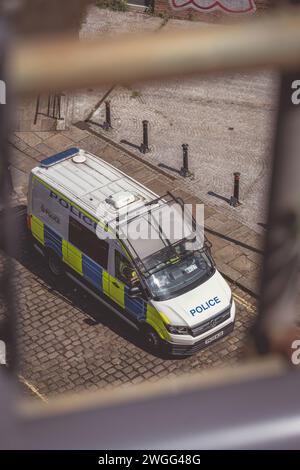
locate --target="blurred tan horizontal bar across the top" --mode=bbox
[10,8,300,93]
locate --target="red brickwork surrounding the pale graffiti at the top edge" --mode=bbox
[153,0,277,23]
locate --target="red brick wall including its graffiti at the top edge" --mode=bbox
[153,0,277,22]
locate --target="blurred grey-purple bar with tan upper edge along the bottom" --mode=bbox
[7,359,300,449]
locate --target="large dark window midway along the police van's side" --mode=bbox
[69,217,109,269]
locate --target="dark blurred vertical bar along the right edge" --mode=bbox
[255,76,300,360]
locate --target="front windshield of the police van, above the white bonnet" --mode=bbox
[144,246,215,301]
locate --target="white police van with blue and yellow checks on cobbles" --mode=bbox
[27,148,235,355]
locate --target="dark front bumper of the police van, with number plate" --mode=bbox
[167,321,234,356]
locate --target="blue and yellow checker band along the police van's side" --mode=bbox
[31,215,170,340]
